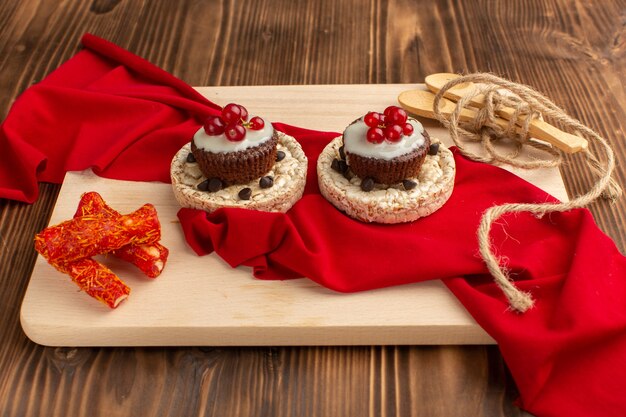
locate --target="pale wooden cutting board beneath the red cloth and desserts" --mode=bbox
[21,84,567,346]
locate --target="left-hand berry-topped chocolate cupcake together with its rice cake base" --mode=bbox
[170,103,308,213]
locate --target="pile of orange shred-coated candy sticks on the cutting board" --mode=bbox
[35,193,168,308]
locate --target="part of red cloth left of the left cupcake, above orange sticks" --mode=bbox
[0,34,220,203]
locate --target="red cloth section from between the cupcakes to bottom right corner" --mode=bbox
[179,124,626,417]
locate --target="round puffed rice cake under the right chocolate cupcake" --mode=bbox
[317,136,456,223]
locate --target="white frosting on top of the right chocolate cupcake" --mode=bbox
[343,118,424,161]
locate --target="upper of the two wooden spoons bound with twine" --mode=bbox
[425,73,589,154]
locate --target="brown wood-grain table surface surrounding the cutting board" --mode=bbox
[0,0,626,417]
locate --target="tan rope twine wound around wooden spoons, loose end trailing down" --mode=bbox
[433,73,622,313]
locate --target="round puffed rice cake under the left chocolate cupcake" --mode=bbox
[170,132,307,213]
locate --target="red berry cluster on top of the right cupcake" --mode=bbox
[363,106,413,143]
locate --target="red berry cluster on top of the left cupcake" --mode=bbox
[204,103,265,142]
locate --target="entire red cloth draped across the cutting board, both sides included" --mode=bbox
[0,35,626,417]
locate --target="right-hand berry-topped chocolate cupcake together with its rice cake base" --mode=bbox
[317,106,455,224]
